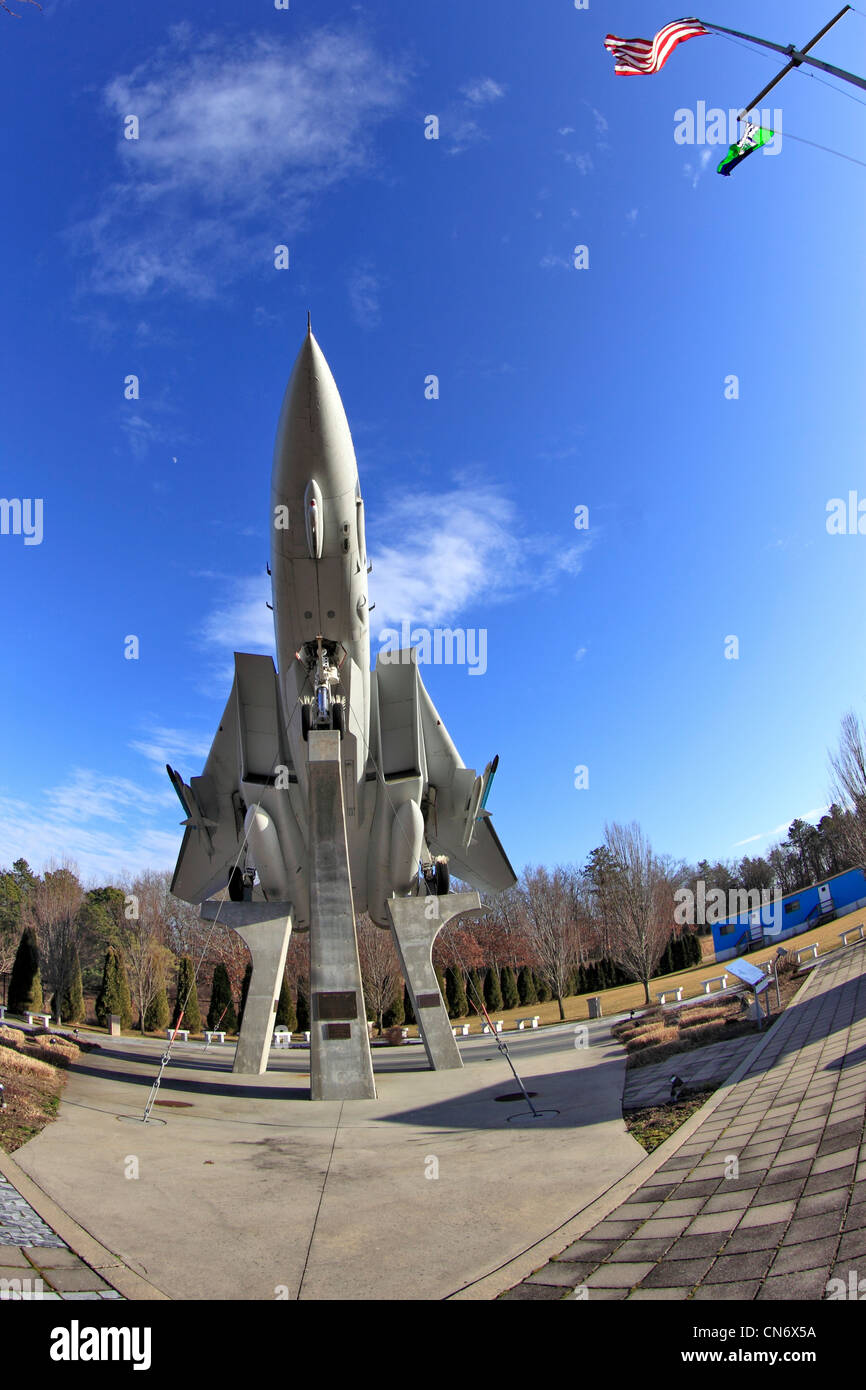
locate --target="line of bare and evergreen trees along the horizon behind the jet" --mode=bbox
[0,712,866,1033]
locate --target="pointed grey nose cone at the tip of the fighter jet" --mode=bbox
[272,318,357,498]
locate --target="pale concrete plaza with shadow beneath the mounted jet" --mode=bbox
[6,1020,644,1300]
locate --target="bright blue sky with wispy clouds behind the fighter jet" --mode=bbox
[0,0,866,880]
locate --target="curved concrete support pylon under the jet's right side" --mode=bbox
[385,892,481,1072]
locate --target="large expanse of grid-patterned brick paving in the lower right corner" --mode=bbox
[500,947,866,1301]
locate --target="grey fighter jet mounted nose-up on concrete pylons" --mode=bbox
[167,321,514,930]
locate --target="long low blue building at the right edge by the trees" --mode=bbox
[713,869,866,960]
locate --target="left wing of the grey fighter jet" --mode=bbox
[167,684,243,902]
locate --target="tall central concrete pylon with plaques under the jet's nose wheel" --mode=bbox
[307,730,375,1101]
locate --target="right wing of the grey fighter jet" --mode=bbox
[418,671,517,892]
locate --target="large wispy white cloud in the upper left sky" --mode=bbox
[71,25,406,299]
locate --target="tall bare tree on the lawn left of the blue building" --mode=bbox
[602,821,678,1004]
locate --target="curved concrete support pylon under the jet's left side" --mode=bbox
[202,902,292,1076]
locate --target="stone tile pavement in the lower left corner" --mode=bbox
[0,1179,122,1302]
